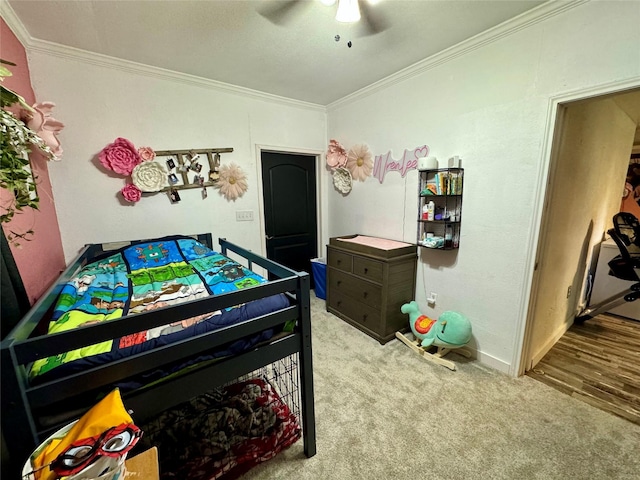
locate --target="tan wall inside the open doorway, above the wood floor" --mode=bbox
[518,84,640,374]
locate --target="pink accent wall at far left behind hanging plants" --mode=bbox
[0,18,65,304]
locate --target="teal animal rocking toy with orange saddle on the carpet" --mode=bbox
[396,301,471,370]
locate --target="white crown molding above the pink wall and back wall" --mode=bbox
[0,0,326,113]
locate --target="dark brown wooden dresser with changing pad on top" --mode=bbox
[327,235,418,344]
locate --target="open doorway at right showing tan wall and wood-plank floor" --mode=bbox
[522,89,640,418]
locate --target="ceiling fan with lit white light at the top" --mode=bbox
[258,0,388,35]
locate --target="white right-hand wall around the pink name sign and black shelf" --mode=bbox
[327,2,640,373]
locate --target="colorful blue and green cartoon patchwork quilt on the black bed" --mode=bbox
[30,236,289,382]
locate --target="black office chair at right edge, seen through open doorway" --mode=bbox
[575,212,640,323]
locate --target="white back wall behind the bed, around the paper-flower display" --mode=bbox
[29,51,326,262]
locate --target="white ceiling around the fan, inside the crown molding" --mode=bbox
[8,0,545,105]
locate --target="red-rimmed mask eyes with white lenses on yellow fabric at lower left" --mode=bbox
[50,423,142,477]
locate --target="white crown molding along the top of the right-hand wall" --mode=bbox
[327,0,591,111]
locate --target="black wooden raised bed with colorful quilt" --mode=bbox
[1,234,316,476]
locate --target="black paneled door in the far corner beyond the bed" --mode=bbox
[260,150,318,288]
